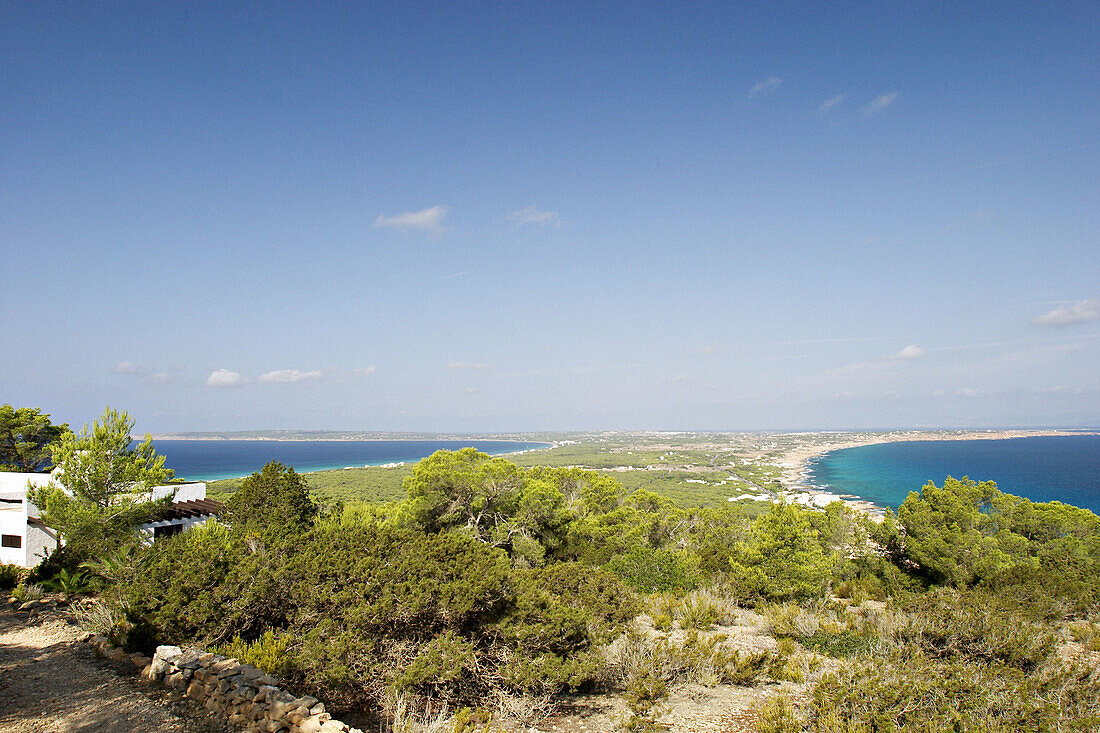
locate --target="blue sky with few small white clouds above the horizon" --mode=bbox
[0,2,1100,431]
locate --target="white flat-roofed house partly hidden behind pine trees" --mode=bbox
[0,471,221,568]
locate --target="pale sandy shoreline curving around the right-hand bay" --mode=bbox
[779,428,1100,517]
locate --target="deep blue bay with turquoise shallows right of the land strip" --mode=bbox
[809,435,1100,514]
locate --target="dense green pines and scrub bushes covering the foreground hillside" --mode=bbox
[21,442,1100,732]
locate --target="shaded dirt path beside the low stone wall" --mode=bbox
[0,606,237,733]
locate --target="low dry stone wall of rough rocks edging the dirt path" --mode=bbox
[90,636,362,733]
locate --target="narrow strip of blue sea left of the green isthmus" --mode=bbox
[153,440,550,481]
